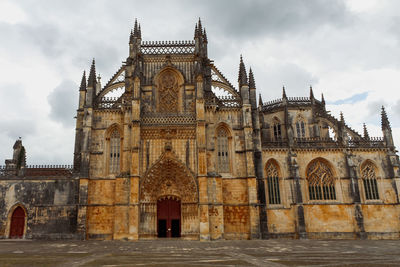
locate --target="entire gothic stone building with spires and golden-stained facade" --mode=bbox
[0,18,400,240]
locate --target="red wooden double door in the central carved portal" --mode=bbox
[157,198,181,237]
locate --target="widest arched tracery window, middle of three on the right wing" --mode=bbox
[306,159,336,200]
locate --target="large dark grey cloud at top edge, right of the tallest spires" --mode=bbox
[188,0,351,38]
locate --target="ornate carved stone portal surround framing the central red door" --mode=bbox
[139,150,199,239]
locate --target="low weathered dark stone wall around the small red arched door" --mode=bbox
[0,177,83,239]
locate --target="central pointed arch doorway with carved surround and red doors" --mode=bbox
[139,151,200,240]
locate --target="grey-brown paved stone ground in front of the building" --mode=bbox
[0,240,400,267]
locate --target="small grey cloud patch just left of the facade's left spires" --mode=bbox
[47,80,78,128]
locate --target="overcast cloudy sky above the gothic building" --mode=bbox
[0,0,400,164]
